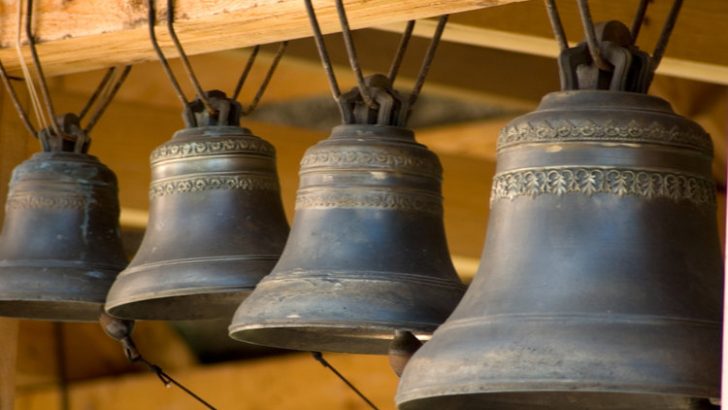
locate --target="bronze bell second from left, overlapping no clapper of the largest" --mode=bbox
[106,91,288,320]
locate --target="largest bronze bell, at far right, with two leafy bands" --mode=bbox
[397,21,723,410]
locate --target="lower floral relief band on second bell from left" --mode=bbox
[149,175,279,198]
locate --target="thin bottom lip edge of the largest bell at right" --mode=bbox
[394,386,720,410]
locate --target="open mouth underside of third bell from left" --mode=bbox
[229,324,436,354]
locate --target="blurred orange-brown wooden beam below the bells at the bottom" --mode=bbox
[16,354,397,410]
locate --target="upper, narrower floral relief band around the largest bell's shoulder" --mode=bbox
[498,120,713,155]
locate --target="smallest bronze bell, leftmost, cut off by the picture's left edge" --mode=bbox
[0,114,126,321]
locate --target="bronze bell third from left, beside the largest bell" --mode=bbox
[230,76,464,354]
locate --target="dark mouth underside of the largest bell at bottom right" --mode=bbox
[398,391,720,410]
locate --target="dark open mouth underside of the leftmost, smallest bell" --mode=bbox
[0,296,103,322]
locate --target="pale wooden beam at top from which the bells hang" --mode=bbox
[0,0,523,75]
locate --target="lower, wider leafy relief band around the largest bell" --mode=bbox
[491,168,715,206]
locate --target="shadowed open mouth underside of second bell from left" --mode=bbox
[106,287,253,320]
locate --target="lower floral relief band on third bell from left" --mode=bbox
[296,190,442,215]
